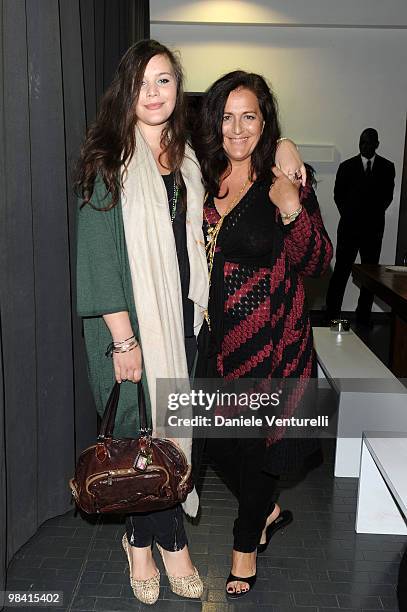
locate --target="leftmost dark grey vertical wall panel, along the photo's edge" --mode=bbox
[2,0,38,558]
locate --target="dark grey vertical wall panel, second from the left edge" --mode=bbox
[27,0,74,520]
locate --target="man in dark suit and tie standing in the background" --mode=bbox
[326,128,395,326]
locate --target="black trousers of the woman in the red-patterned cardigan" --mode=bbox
[206,438,278,552]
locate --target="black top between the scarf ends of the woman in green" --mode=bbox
[161,172,194,338]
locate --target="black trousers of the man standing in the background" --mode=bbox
[326,219,384,322]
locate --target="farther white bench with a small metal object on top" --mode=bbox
[313,327,407,478]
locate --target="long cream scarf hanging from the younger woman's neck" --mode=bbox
[122,127,208,516]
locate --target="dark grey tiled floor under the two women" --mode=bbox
[7,318,407,612]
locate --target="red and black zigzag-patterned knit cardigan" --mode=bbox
[198,181,332,472]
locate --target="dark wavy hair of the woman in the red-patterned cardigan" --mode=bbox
[193,70,280,197]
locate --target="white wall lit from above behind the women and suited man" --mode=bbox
[151,0,407,310]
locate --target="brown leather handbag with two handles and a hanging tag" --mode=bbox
[69,382,193,514]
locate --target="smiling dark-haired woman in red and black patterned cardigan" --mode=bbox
[194,70,332,598]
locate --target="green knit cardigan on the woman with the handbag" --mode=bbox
[76,177,151,437]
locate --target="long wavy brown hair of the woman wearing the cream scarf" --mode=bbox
[75,40,186,210]
